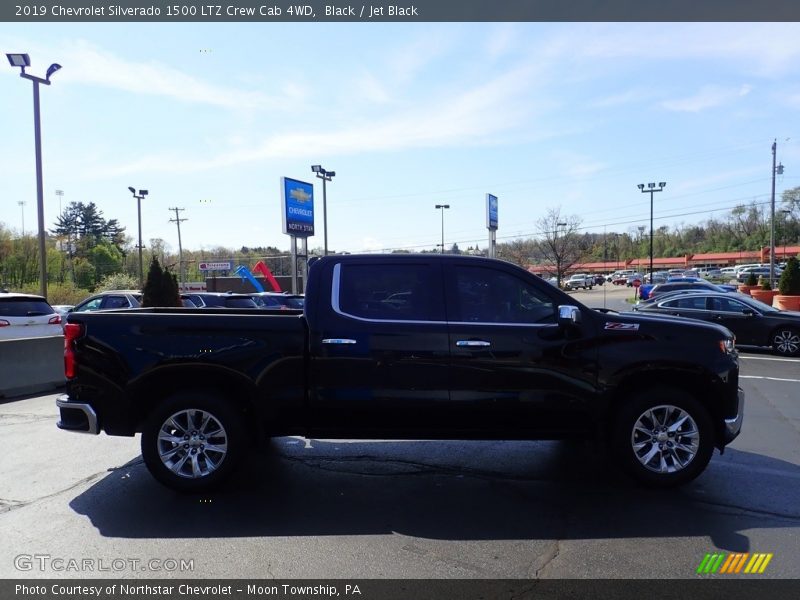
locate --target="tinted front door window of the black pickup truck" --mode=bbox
[451,266,556,324]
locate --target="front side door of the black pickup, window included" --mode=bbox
[445,261,597,437]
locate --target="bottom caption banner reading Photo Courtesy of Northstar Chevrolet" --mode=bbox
[0,576,800,600]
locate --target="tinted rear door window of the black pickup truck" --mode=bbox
[338,263,444,321]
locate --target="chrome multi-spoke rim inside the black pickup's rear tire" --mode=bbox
[158,408,228,479]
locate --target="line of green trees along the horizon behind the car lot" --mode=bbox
[0,187,800,304]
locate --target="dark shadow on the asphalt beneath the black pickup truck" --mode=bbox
[70,438,800,552]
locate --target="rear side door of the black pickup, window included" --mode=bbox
[309,257,450,435]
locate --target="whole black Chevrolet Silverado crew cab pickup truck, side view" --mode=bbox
[57,254,744,491]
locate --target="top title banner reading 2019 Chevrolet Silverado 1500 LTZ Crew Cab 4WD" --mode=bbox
[0,0,800,23]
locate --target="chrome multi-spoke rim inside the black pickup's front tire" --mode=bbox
[631,404,700,473]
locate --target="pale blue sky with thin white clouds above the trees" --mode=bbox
[0,23,800,252]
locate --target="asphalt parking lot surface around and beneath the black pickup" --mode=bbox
[0,288,800,579]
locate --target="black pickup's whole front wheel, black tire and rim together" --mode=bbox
[611,388,714,488]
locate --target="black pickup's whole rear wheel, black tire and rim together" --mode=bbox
[142,391,245,493]
